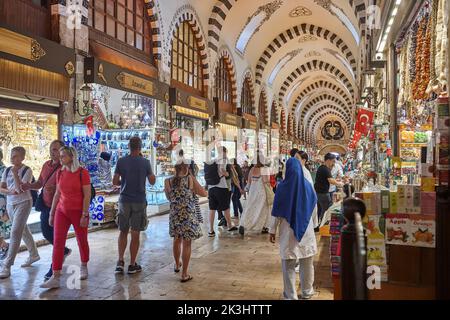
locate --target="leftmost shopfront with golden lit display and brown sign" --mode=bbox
[0,23,75,224]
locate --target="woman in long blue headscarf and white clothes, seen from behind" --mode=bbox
[269,158,317,300]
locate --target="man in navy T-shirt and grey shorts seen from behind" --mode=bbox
[113,137,156,274]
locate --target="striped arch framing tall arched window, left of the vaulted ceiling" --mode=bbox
[165,5,209,91]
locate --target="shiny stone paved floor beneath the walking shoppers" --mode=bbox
[0,206,333,300]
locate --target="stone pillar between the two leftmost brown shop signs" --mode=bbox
[51,0,89,124]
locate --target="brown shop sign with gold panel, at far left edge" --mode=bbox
[0,23,75,77]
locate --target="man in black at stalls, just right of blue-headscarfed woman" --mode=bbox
[314,153,342,231]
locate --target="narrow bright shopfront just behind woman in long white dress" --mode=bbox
[238,115,258,165]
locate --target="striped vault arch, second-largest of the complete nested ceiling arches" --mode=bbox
[279,60,355,103]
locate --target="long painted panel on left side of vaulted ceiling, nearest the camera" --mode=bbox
[235,0,283,55]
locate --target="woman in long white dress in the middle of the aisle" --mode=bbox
[239,156,272,235]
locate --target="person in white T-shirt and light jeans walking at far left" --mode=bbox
[0,147,40,279]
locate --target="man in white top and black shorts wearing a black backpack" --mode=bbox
[205,147,237,237]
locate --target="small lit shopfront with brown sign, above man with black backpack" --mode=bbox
[214,99,242,159]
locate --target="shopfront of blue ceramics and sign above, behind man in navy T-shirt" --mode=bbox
[63,57,173,218]
